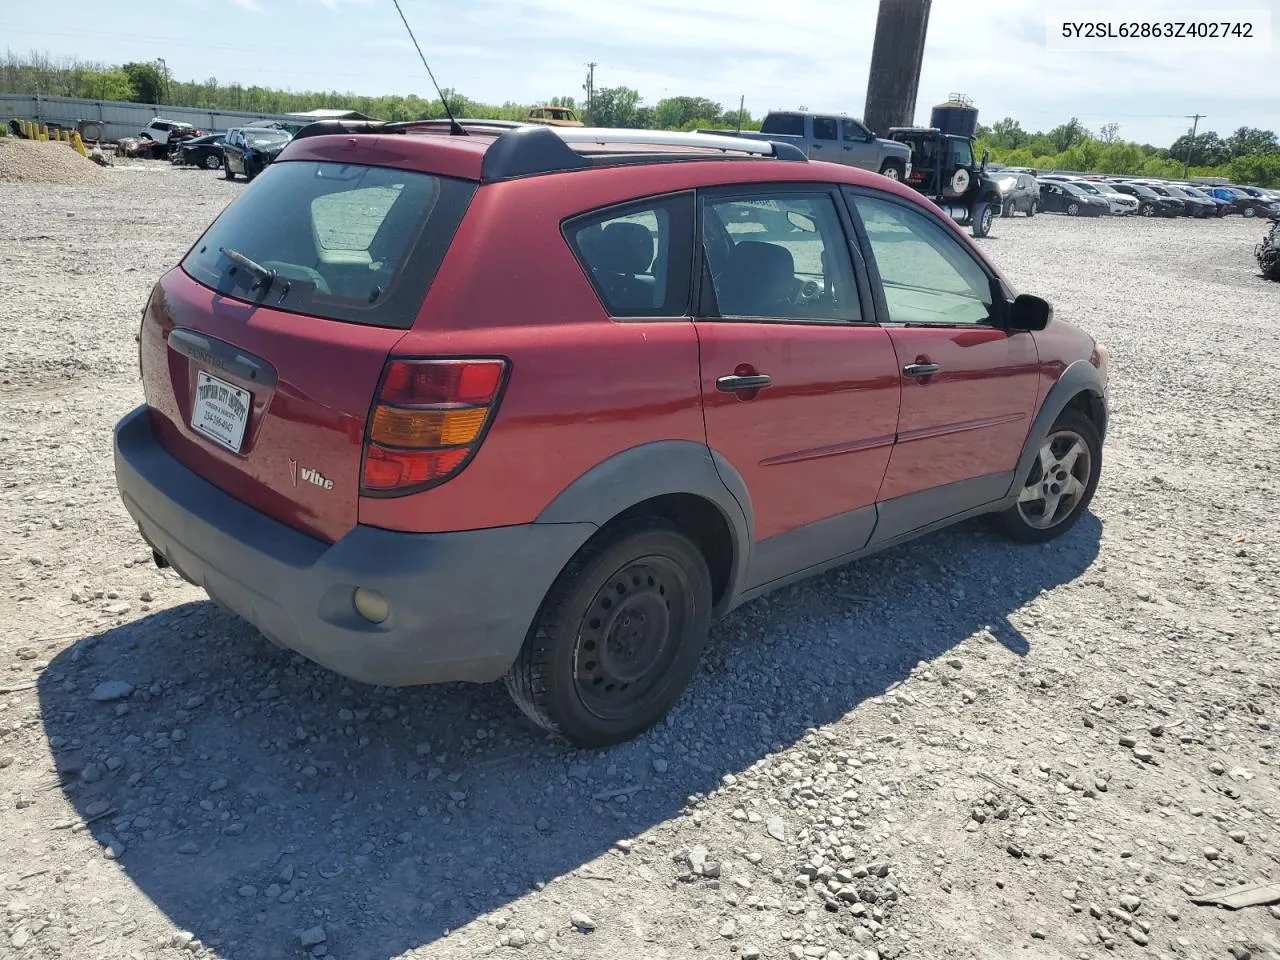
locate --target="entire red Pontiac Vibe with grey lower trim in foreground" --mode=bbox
[114,120,1108,746]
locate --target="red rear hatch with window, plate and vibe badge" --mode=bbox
[140,160,476,541]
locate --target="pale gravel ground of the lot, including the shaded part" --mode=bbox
[0,164,1280,960]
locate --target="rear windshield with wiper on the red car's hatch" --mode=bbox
[182,160,476,328]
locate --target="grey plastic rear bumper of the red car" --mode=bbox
[115,406,595,686]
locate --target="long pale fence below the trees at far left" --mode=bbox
[0,93,298,140]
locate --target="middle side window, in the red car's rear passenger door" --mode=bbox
[701,193,861,321]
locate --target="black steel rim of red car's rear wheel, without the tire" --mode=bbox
[573,557,692,721]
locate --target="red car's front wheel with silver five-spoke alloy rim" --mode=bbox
[992,408,1102,543]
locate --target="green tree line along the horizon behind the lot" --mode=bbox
[0,51,1280,187]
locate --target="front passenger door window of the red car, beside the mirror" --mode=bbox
[850,193,996,326]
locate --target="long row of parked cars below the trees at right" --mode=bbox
[991,166,1280,219]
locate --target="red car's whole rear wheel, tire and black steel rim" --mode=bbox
[506,520,712,748]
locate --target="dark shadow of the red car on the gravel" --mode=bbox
[38,515,1102,960]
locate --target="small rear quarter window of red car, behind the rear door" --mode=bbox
[564,193,694,317]
